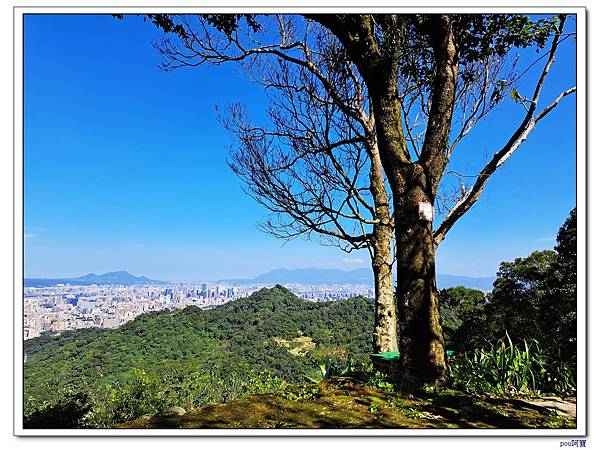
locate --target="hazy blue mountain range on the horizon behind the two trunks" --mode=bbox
[219,268,495,291]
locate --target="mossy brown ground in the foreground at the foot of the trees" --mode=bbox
[118,377,575,429]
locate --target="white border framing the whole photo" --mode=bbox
[13,1,588,438]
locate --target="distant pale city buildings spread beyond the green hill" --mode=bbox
[23,283,374,339]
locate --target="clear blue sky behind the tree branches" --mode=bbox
[24,15,576,281]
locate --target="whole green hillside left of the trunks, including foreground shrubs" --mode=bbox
[24,286,373,426]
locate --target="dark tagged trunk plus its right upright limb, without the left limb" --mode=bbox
[388,15,458,385]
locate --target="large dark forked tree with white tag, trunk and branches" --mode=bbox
[123,14,575,382]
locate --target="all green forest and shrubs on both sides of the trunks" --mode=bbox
[24,210,577,428]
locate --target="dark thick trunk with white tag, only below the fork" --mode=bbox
[394,174,447,385]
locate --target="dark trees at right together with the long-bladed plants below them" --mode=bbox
[440,209,577,394]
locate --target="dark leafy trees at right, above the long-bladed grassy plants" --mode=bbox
[452,210,577,362]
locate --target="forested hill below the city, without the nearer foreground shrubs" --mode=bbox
[24,286,373,426]
